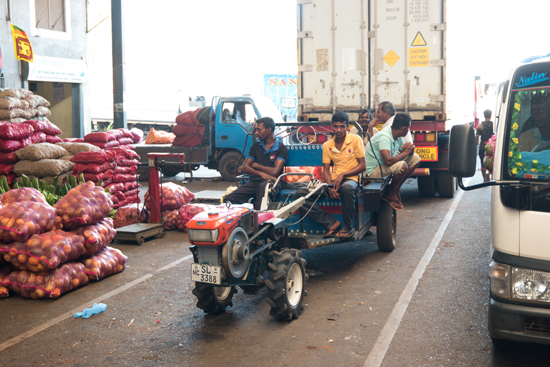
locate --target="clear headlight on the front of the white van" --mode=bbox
[512,268,550,302]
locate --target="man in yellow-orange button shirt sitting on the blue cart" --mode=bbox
[296,112,366,237]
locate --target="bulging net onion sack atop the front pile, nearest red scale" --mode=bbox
[54,181,113,229]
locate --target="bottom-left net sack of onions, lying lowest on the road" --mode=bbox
[4,262,89,299]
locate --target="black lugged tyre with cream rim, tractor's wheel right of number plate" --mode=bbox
[265,248,306,321]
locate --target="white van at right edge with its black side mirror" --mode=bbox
[449,58,550,347]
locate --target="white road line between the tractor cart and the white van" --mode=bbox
[364,179,470,367]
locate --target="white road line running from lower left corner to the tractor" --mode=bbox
[0,255,193,352]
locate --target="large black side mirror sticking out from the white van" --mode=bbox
[449,124,477,177]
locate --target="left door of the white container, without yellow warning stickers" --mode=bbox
[298,0,368,113]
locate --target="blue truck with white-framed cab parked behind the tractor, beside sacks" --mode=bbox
[134,95,283,181]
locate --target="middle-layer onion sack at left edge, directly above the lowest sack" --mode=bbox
[0,229,86,273]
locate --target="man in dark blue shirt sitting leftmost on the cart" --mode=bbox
[224,117,288,210]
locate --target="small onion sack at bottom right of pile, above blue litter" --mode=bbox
[79,247,128,280]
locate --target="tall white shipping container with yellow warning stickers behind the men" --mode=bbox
[298,0,446,121]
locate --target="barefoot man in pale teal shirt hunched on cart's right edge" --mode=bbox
[365,113,420,210]
